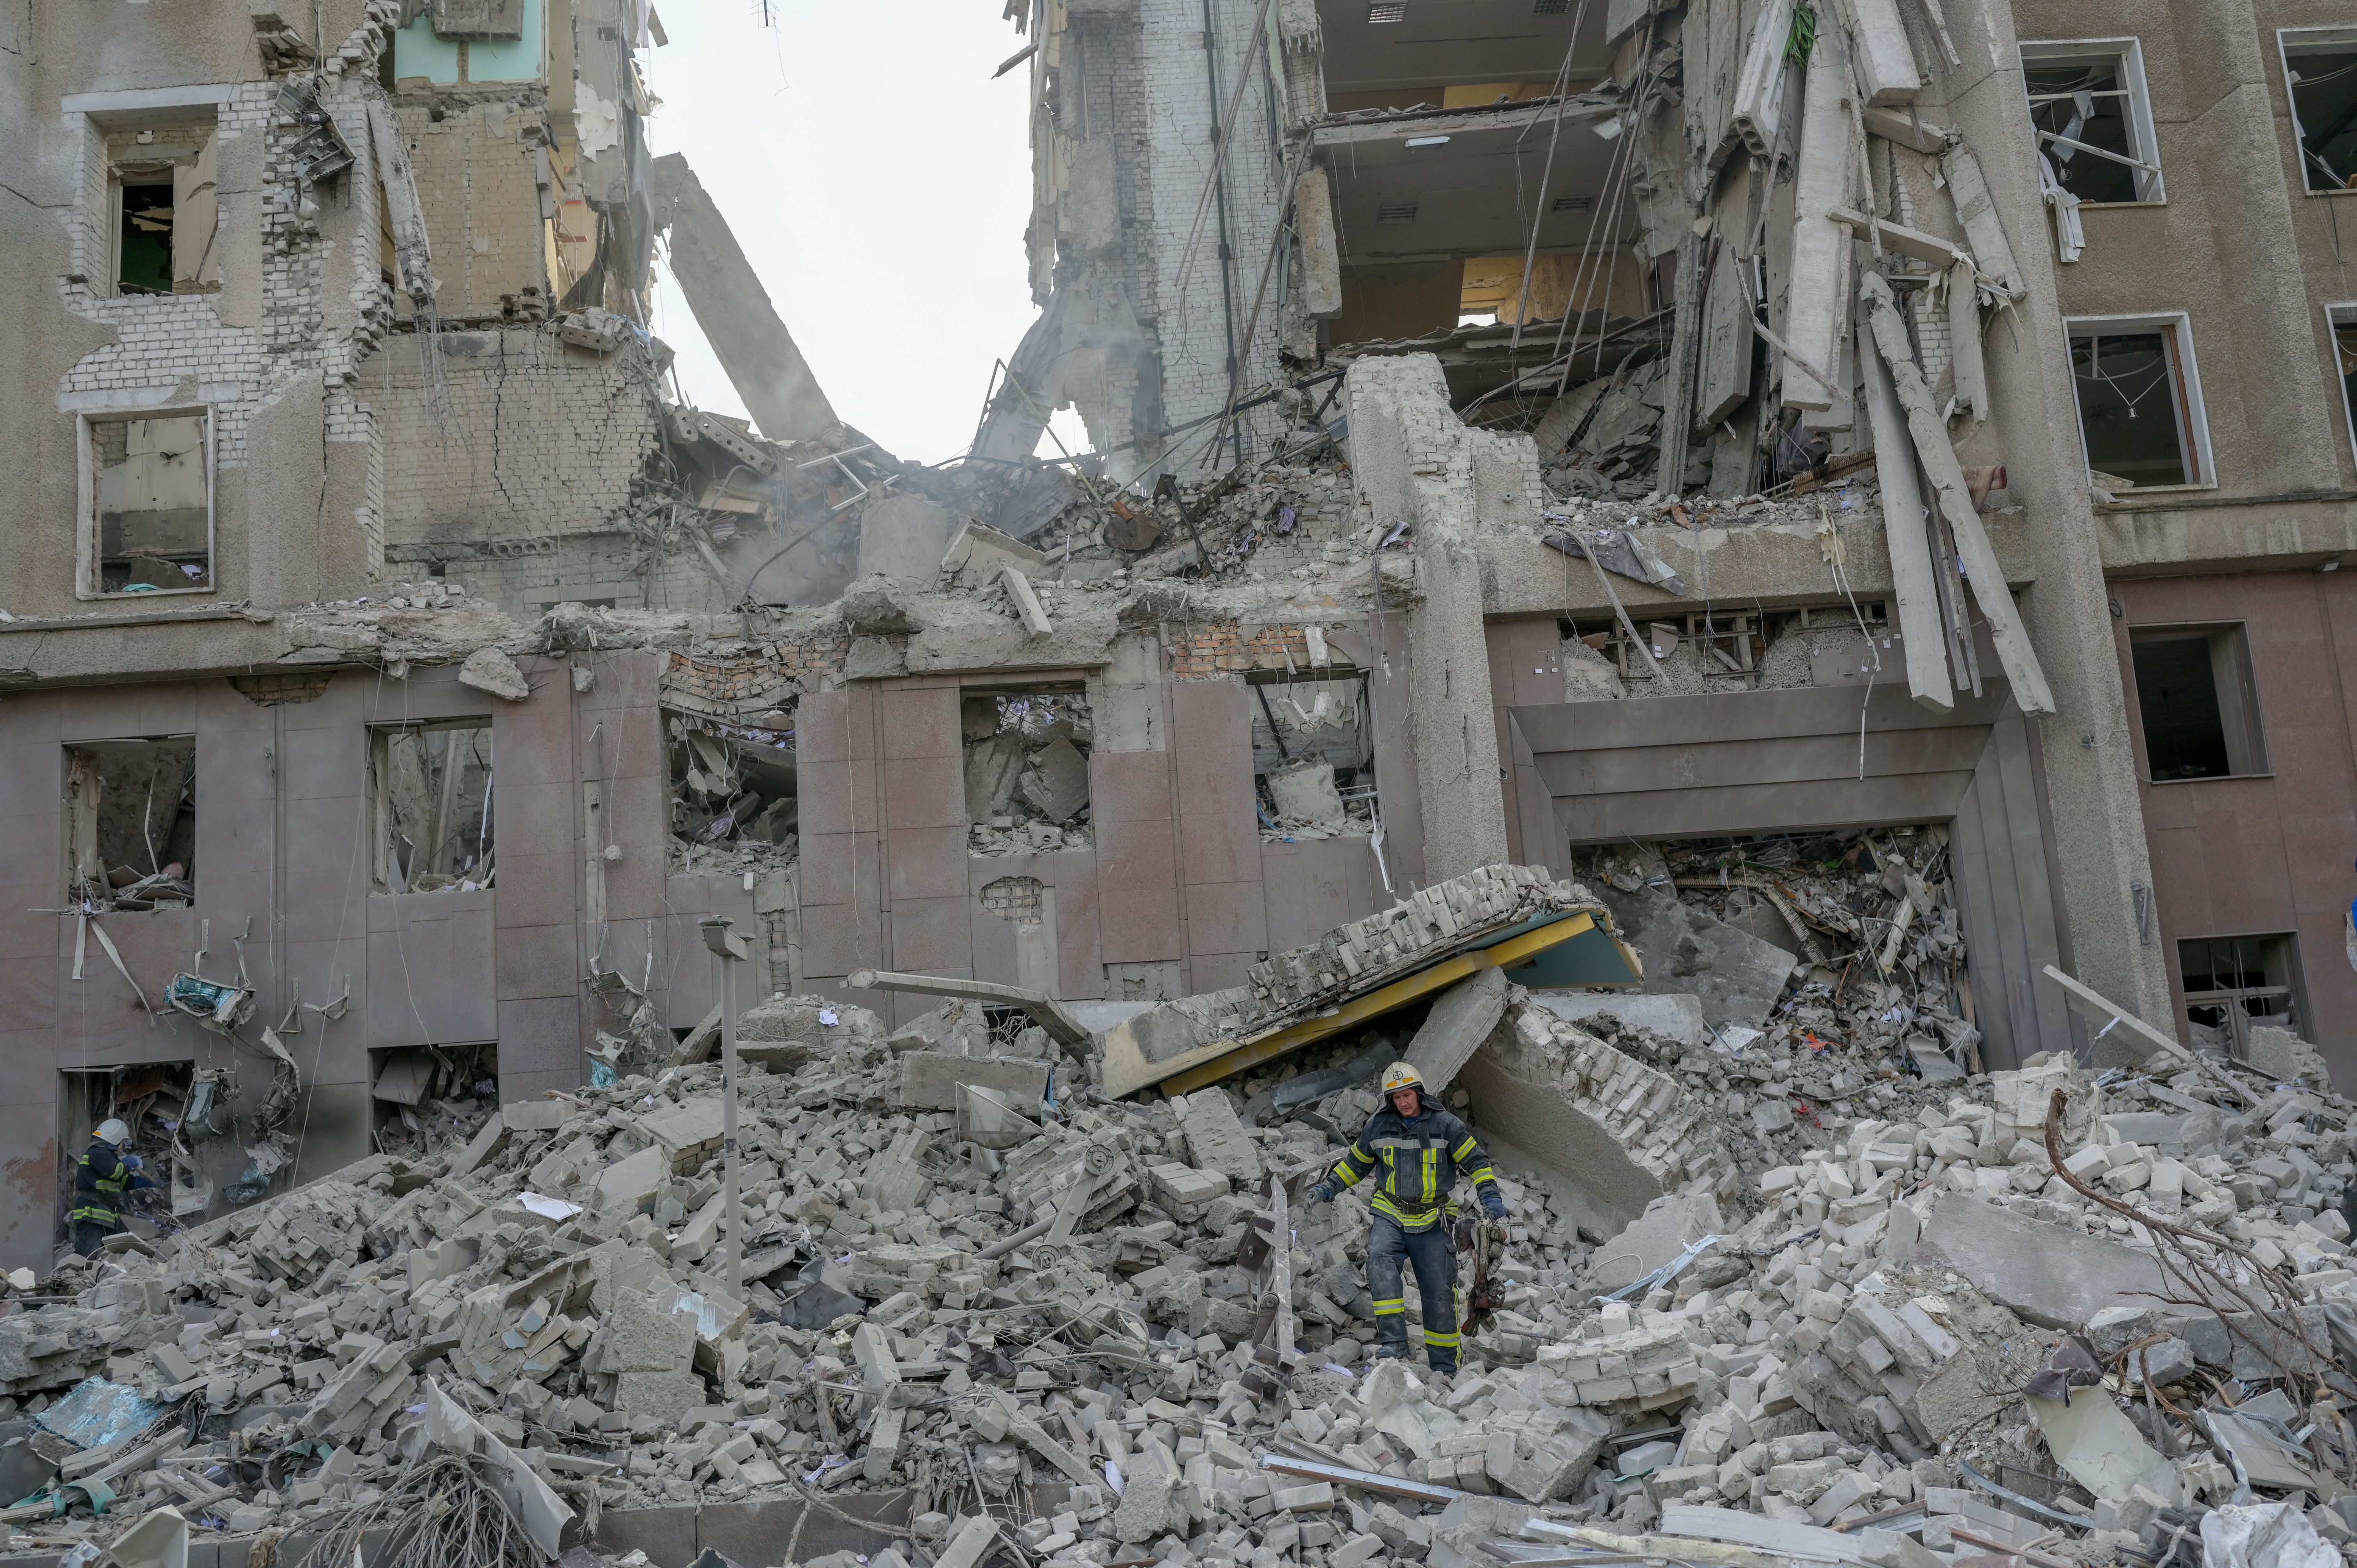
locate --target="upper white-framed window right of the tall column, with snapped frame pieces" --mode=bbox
[2022,38,2166,203]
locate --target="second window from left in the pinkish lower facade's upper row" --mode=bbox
[368,719,497,893]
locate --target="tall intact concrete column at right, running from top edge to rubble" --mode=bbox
[1923,0,2173,1026]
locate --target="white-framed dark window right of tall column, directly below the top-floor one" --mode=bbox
[2069,314,2216,491]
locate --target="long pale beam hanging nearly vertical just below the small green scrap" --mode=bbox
[1784,28,1853,412]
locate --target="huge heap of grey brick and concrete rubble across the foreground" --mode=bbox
[14,966,2357,1568]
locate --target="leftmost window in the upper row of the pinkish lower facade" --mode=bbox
[66,736,196,910]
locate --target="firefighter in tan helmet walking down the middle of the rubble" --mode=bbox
[1311,1061,1506,1375]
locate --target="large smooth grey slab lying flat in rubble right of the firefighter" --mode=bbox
[1914,1193,2168,1330]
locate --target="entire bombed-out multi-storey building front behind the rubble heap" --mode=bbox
[0,0,2357,1330]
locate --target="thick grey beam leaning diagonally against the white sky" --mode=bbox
[653,153,834,441]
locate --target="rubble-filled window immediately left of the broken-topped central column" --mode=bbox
[1249,672,1376,842]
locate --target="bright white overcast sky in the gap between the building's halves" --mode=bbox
[646,0,1070,462]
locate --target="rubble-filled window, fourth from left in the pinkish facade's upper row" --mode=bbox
[964,689,1096,856]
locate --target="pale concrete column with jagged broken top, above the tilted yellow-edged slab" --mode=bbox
[1346,354,1537,891]
